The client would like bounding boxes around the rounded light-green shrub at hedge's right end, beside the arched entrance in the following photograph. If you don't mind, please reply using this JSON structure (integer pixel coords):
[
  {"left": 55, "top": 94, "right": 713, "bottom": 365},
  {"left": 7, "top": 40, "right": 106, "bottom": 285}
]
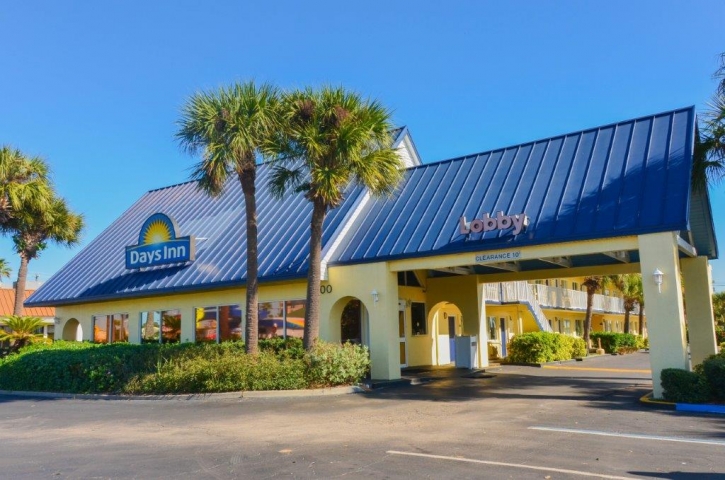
[{"left": 307, "top": 341, "right": 370, "bottom": 387}]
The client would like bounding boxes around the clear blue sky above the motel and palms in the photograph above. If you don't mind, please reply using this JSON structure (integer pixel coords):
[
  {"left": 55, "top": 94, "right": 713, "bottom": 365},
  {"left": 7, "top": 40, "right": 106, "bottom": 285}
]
[{"left": 0, "top": 0, "right": 725, "bottom": 288}]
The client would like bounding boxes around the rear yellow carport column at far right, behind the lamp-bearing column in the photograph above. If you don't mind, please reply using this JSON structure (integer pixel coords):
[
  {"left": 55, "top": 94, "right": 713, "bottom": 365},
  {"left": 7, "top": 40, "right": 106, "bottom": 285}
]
[{"left": 680, "top": 257, "right": 717, "bottom": 366}]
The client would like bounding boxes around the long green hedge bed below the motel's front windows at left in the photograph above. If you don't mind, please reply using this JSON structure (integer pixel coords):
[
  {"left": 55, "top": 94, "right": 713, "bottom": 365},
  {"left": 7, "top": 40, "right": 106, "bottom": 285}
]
[{"left": 0, "top": 339, "right": 370, "bottom": 394}]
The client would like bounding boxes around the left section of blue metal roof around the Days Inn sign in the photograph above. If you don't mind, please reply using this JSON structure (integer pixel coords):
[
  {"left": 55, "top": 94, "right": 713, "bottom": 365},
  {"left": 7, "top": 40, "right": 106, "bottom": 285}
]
[{"left": 26, "top": 165, "right": 362, "bottom": 305}]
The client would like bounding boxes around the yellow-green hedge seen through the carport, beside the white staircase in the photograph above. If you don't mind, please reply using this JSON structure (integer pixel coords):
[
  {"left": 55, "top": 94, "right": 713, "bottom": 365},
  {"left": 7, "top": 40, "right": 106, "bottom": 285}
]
[{"left": 507, "top": 332, "right": 587, "bottom": 363}]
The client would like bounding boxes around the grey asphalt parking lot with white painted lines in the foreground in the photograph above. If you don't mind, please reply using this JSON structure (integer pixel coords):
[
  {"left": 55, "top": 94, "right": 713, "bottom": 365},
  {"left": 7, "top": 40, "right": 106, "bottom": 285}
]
[{"left": 0, "top": 353, "right": 725, "bottom": 479}]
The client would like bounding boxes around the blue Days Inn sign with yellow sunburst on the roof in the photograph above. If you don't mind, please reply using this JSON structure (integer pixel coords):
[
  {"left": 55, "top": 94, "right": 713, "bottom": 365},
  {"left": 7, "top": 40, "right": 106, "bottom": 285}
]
[{"left": 126, "top": 213, "right": 196, "bottom": 270}]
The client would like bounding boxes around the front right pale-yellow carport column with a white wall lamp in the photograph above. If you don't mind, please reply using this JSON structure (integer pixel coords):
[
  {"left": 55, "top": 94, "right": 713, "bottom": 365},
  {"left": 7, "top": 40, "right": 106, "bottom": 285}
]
[{"left": 639, "top": 232, "right": 690, "bottom": 398}]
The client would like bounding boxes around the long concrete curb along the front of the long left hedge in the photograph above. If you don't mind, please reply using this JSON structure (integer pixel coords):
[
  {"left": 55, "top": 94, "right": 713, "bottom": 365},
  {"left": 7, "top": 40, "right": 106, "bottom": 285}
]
[{"left": 0, "top": 385, "right": 369, "bottom": 402}]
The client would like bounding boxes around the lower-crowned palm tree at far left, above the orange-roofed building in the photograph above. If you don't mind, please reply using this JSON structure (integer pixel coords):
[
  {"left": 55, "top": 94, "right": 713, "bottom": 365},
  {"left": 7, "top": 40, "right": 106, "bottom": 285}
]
[{"left": 10, "top": 197, "right": 83, "bottom": 315}]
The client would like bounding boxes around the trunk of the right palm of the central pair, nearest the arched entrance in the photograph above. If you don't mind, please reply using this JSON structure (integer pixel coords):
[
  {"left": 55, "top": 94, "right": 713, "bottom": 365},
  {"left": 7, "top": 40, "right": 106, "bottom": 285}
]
[{"left": 303, "top": 200, "right": 327, "bottom": 350}]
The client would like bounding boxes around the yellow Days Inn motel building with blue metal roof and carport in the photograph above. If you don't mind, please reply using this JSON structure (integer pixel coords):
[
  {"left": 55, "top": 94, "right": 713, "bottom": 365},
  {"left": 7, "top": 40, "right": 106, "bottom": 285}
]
[{"left": 27, "top": 107, "right": 718, "bottom": 394}]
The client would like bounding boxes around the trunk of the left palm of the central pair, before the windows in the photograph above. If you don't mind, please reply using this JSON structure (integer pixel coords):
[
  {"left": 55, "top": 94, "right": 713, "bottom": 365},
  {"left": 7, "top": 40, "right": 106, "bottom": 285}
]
[{"left": 238, "top": 171, "right": 259, "bottom": 354}]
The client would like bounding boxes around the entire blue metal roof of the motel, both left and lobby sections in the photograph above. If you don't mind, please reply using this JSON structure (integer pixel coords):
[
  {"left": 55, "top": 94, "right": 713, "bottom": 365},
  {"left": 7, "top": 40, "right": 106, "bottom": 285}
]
[{"left": 26, "top": 107, "right": 699, "bottom": 306}]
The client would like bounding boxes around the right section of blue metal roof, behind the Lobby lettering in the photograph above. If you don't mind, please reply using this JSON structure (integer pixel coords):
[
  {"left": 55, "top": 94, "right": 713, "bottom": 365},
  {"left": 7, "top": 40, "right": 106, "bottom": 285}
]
[{"left": 331, "top": 107, "right": 695, "bottom": 263}]
